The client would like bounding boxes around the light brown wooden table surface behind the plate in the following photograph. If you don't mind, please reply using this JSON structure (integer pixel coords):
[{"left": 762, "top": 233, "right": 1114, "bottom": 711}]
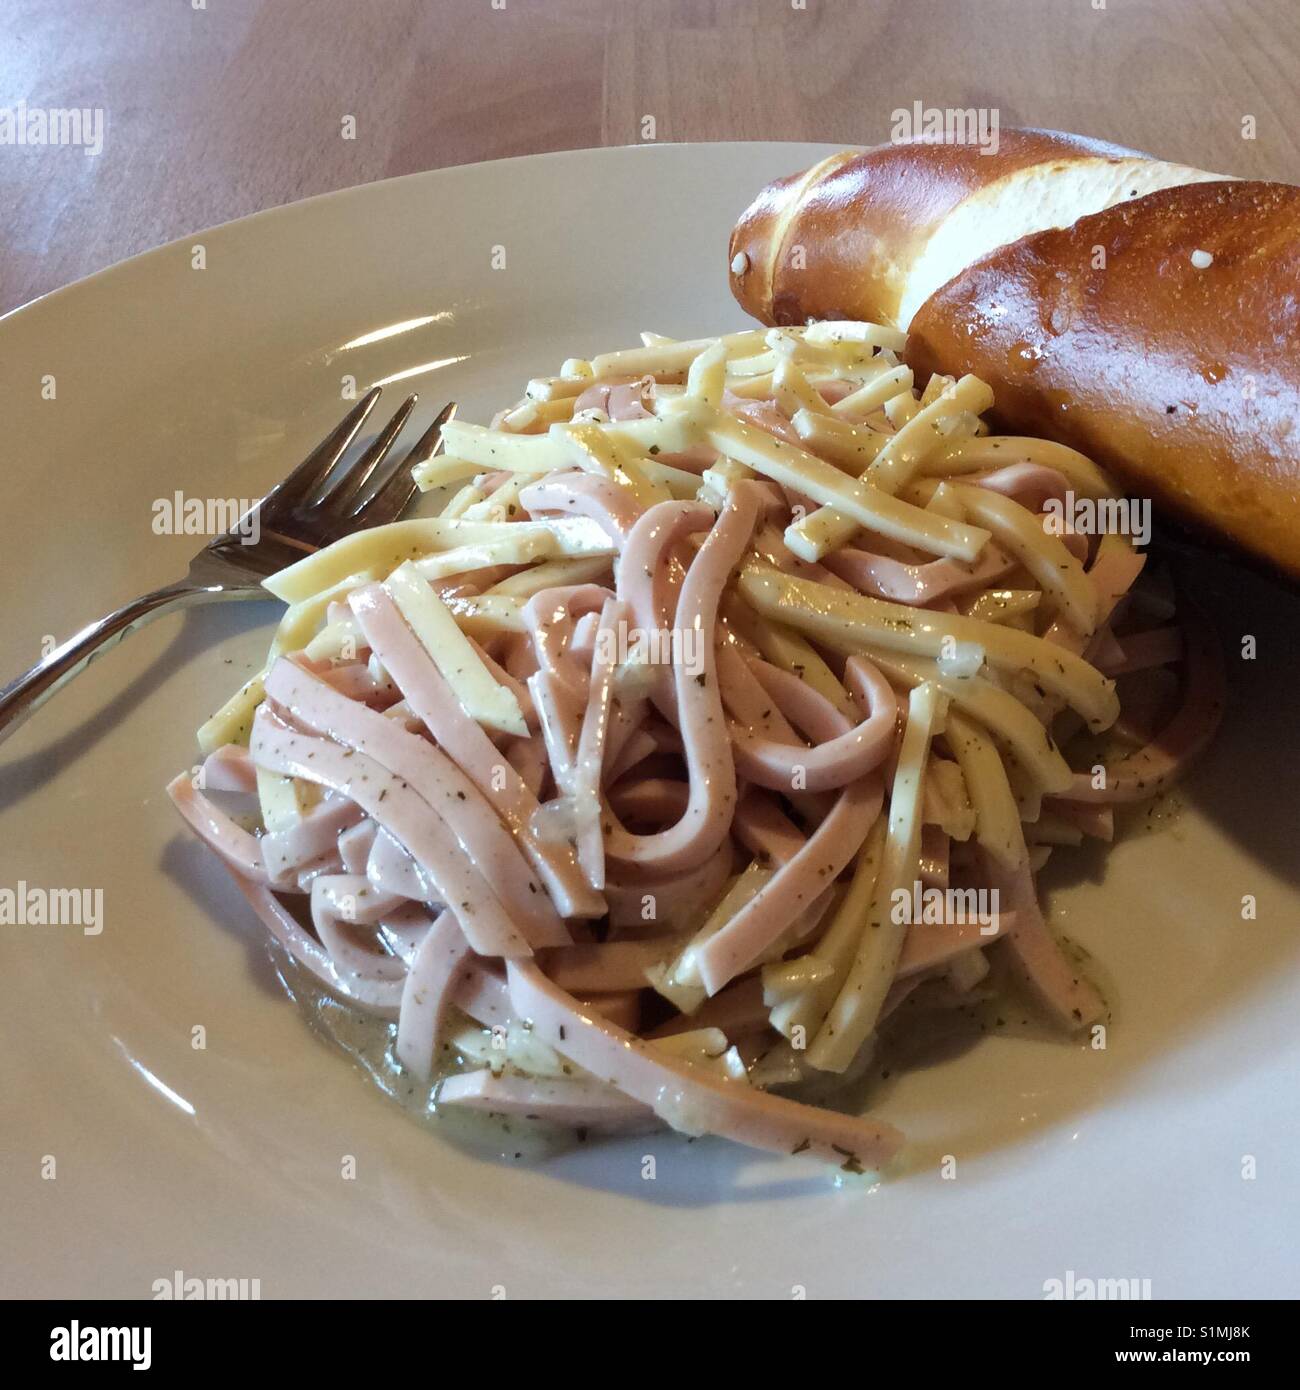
[{"left": 0, "top": 0, "right": 1300, "bottom": 310}]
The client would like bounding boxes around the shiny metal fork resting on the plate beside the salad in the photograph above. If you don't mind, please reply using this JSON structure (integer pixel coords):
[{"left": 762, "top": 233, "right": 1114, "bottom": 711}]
[{"left": 0, "top": 386, "right": 456, "bottom": 741}]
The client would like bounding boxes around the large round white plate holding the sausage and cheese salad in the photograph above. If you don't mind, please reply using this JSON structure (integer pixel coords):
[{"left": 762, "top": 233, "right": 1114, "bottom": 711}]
[{"left": 0, "top": 145, "right": 1300, "bottom": 1297}]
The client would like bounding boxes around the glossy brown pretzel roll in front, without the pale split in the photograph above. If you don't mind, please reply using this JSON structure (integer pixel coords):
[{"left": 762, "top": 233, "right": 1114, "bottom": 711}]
[{"left": 907, "top": 182, "right": 1300, "bottom": 578}]
